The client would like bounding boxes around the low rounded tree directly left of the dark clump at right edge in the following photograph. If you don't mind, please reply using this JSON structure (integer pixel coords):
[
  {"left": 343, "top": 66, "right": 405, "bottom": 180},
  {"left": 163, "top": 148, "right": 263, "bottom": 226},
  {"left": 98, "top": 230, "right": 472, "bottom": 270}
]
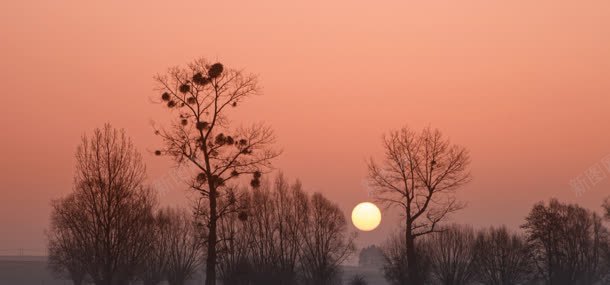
[{"left": 475, "top": 226, "right": 536, "bottom": 285}]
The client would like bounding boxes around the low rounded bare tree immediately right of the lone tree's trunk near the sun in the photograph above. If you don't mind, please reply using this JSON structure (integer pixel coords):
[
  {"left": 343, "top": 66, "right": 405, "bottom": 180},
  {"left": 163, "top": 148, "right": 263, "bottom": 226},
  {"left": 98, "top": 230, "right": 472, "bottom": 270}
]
[{"left": 426, "top": 225, "right": 477, "bottom": 285}]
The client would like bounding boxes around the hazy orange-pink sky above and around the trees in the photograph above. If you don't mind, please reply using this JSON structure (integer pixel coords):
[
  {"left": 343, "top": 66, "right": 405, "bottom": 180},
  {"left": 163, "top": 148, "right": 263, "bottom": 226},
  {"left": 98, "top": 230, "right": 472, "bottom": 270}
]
[{"left": 0, "top": 0, "right": 610, "bottom": 254}]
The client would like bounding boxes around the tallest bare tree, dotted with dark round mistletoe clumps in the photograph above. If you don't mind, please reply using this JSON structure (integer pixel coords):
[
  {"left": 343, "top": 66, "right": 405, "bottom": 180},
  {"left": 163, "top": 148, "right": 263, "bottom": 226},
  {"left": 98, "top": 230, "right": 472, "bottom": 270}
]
[{"left": 155, "top": 59, "right": 279, "bottom": 285}]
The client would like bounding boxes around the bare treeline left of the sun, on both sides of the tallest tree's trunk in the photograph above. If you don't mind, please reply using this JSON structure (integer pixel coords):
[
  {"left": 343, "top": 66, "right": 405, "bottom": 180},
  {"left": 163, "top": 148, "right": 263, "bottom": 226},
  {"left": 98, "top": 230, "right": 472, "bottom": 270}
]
[{"left": 47, "top": 125, "right": 355, "bottom": 285}]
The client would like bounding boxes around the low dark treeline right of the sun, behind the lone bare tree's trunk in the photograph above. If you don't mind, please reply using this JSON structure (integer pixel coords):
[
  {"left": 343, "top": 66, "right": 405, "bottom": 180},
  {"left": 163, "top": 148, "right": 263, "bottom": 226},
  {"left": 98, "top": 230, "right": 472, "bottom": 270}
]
[{"left": 383, "top": 199, "right": 610, "bottom": 285}]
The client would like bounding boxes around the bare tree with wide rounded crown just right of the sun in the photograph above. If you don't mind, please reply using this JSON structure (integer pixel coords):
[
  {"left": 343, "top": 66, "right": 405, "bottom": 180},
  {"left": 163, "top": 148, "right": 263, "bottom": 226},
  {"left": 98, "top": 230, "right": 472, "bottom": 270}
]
[{"left": 368, "top": 127, "right": 471, "bottom": 284}]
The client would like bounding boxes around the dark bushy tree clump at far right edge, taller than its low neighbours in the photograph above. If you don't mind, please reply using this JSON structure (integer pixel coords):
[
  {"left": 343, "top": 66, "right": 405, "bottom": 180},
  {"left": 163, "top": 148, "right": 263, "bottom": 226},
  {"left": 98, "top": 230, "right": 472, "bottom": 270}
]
[{"left": 522, "top": 199, "right": 610, "bottom": 285}]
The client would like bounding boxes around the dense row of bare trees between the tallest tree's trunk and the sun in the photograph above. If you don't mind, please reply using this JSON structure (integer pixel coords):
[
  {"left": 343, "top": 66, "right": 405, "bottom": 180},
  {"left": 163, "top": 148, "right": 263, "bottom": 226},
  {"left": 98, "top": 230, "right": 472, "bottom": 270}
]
[{"left": 208, "top": 174, "right": 355, "bottom": 285}]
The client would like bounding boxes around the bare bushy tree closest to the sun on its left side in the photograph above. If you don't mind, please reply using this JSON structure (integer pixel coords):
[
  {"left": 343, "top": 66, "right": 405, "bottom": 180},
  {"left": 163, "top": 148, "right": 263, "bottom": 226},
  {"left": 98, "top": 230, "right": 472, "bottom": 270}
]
[{"left": 301, "top": 193, "right": 355, "bottom": 285}]
